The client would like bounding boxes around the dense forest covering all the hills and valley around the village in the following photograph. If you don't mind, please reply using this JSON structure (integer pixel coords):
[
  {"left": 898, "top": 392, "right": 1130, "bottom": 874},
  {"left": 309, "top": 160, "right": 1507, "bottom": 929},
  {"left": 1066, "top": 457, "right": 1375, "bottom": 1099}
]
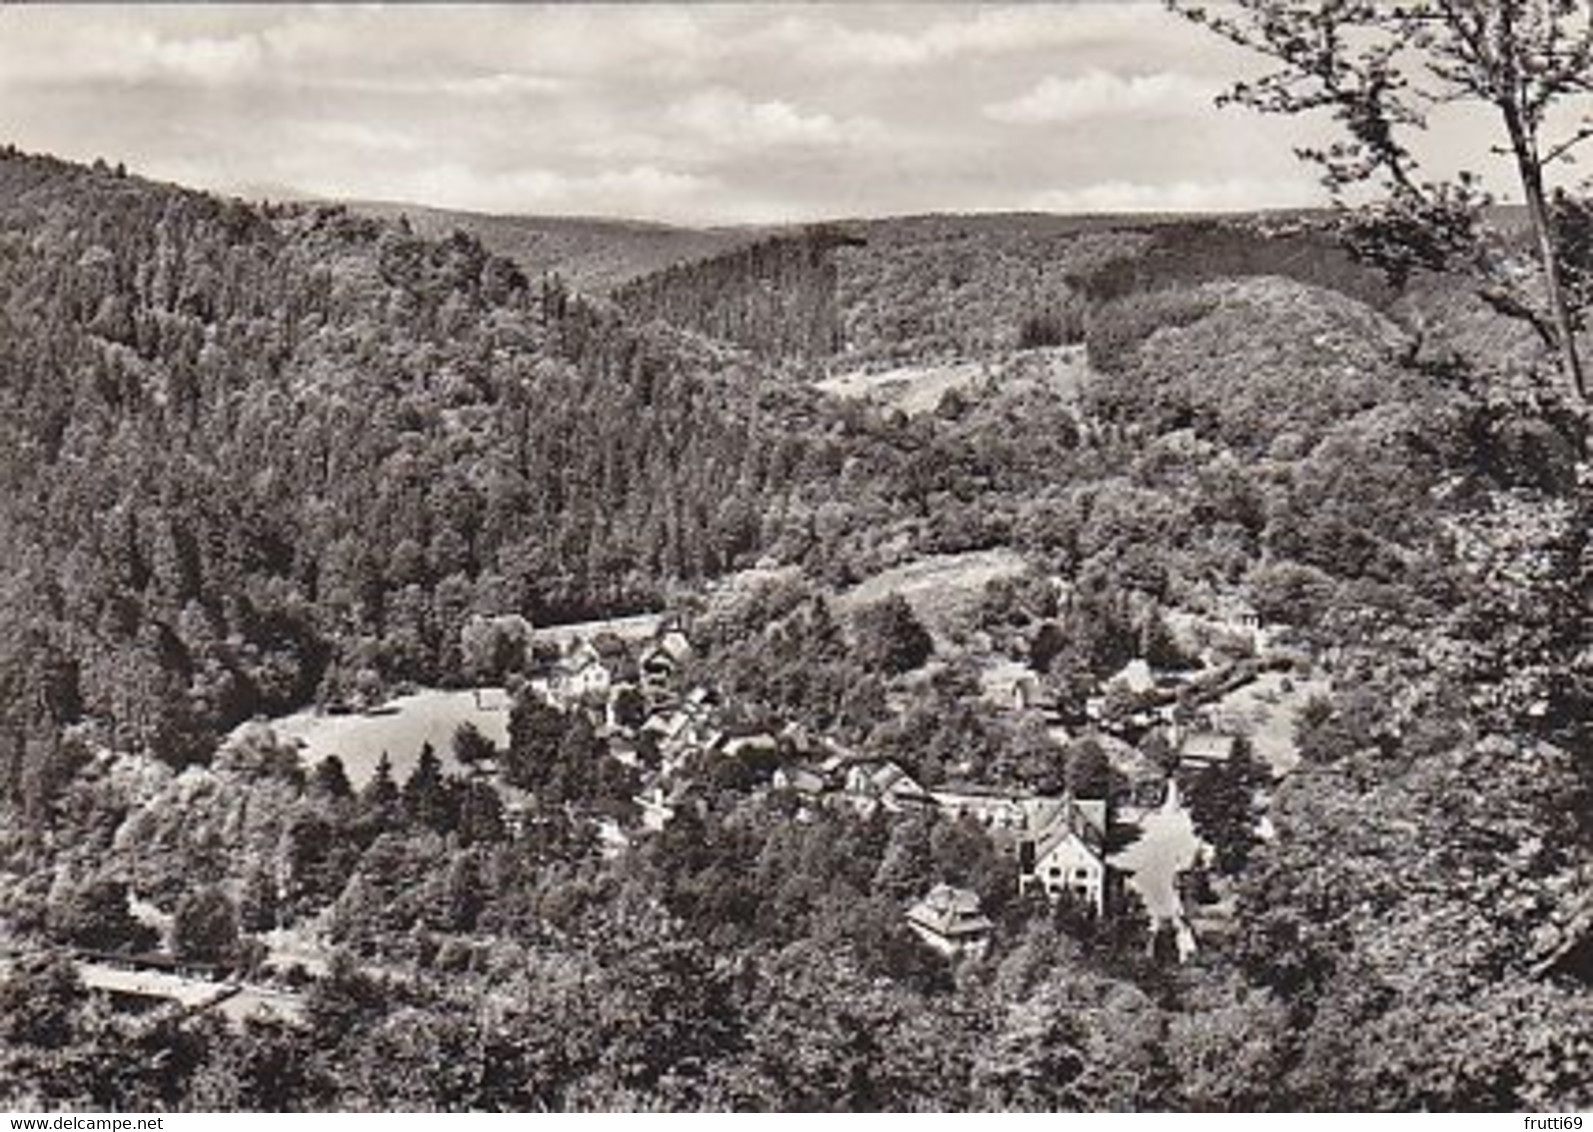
[{"left": 0, "top": 150, "right": 1593, "bottom": 1110}]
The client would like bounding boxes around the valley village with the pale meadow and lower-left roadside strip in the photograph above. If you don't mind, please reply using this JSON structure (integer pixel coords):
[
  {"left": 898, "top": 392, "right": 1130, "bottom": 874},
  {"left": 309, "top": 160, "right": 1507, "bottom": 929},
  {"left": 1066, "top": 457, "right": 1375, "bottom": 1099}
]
[{"left": 6, "top": 579, "right": 1325, "bottom": 1021}]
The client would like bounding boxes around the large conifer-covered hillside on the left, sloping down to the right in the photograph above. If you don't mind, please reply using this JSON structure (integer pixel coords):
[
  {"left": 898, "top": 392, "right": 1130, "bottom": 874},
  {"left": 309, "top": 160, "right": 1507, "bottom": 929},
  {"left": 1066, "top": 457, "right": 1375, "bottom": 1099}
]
[{"left": 0, "top": 151, "right": 860, "bottom": 791}]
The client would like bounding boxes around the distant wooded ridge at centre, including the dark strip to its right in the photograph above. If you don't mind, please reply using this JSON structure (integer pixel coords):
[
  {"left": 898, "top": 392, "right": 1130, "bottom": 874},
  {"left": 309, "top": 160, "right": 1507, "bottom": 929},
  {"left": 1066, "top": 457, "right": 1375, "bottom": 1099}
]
[{"left": 613, "top": 212, "right": 1392, "bottom": 374}]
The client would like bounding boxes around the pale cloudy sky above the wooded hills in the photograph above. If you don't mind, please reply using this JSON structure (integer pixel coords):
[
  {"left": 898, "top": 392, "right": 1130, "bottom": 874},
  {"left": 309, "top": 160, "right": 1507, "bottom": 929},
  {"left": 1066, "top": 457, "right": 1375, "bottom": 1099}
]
[{"left": 0, "top": 0, "right": 1497, "bottom": 224}]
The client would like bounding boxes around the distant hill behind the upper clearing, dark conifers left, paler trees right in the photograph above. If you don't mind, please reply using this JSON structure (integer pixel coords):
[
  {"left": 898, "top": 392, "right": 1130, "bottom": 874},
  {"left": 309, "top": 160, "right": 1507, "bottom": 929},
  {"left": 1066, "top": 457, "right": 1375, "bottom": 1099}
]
[{"left": 615, "top": 215, "right": 1121, "bottom": 373}]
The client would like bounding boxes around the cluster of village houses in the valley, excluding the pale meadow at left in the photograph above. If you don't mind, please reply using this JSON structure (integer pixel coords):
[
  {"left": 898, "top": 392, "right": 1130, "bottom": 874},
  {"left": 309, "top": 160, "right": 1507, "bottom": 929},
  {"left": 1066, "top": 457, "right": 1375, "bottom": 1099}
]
[{"left": 465, "top": 585, "right": 1327, "bottom": 958}]
